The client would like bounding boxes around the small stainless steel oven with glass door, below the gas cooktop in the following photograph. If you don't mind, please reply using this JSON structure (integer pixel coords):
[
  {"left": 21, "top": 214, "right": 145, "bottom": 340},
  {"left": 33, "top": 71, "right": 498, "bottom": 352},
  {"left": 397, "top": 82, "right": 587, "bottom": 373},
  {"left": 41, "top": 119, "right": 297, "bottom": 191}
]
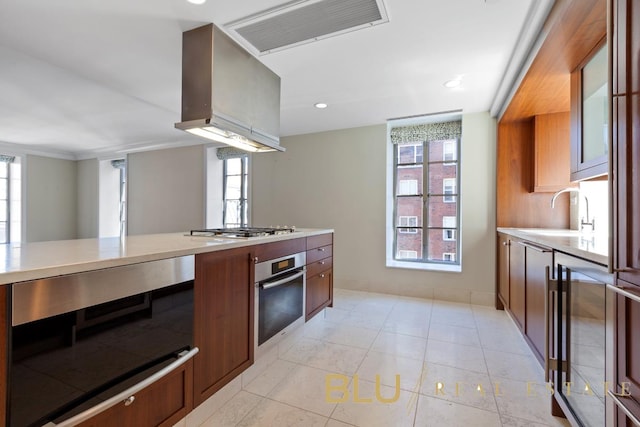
[{"left": 255, "top": 252, "right": 306, "bottom": 356}]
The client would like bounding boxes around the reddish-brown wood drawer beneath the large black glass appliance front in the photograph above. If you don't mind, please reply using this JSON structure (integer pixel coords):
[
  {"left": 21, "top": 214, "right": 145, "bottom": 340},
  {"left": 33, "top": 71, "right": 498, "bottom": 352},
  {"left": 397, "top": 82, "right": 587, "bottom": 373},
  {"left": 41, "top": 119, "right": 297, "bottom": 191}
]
[{"left": 79, "top": 360, "right": 193, "bottom": 427}]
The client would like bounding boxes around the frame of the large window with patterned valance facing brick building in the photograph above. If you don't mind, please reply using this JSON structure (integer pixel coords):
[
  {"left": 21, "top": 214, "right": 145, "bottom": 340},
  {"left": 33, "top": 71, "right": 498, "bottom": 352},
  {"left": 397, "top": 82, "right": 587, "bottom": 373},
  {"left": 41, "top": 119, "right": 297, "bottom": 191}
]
[{"left": 386, "top": 116, "right": 462, "bottom": 272}]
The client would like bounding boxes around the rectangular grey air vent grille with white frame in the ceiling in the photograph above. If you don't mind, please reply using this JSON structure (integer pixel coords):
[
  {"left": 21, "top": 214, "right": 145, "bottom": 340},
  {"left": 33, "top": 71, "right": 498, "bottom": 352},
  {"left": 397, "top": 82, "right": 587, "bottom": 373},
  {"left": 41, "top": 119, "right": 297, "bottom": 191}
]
[{"left": 225, "top": 0, "right": 389, "bottom": 55}]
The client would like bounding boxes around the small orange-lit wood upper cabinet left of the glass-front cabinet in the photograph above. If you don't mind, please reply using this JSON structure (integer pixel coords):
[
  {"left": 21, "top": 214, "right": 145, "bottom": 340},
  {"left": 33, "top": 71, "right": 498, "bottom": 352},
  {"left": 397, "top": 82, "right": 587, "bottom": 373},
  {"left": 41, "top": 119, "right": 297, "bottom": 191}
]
[{"left": 532, "top": 112, "right": 571, "bottom": 192}]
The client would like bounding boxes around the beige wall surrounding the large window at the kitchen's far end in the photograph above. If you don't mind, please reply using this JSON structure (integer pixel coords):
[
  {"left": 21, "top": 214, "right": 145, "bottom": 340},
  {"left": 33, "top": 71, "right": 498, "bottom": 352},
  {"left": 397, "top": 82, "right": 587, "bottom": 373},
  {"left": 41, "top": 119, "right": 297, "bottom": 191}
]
[{"left": 251, "top": 113, "right": 496, "bottom": 305}]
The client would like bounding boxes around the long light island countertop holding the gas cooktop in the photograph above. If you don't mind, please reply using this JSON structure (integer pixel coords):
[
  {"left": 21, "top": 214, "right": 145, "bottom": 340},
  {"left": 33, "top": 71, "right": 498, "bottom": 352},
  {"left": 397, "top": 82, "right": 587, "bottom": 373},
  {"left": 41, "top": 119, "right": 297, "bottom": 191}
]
[{"left": 0, "top": 228, "right": 333, "bottom": 284}]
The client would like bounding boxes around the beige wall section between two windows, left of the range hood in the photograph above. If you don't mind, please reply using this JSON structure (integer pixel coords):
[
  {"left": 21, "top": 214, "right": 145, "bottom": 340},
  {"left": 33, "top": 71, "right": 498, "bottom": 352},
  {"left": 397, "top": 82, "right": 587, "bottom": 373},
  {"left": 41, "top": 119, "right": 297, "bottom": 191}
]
[{"left": 127, "top": 145, "right": 206, "bottom": 234}]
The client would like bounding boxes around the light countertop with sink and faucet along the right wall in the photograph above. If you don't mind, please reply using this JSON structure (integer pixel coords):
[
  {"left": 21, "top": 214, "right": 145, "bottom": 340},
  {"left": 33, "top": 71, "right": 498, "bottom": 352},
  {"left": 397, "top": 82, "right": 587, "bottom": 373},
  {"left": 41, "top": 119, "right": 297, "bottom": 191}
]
[{"left": 498, "top": 227, "right": 609, "bottom": 266}]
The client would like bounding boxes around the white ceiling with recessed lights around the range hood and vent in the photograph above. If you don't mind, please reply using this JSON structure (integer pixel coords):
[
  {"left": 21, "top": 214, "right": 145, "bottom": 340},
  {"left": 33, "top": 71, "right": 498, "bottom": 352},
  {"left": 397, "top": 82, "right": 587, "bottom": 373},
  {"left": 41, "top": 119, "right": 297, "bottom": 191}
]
[{"left": 0, "top": 0, "right": 553, "bottom": 158}]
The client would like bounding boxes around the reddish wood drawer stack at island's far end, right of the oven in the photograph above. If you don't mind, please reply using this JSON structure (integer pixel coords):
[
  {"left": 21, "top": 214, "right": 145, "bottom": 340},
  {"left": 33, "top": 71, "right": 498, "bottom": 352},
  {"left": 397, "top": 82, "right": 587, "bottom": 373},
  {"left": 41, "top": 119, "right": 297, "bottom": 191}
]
[{"left": 305, "top": 233, "right": 333, "bottom": 321}]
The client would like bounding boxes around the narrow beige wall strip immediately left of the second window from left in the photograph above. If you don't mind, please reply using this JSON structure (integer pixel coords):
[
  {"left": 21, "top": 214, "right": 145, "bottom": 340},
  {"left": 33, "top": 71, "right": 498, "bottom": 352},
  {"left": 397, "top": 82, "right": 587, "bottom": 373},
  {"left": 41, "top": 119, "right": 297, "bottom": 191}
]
[{"left": 76, "top": 159, "right": 98, "bottom": 239}]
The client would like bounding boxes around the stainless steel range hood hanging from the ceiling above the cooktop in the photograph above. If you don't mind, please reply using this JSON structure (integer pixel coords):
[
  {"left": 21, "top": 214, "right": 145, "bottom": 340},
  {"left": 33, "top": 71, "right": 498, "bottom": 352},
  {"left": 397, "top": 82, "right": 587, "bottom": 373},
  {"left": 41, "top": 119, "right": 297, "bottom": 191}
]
[{"left": 175, "top": 24, "right": 285, "bottom": 152}]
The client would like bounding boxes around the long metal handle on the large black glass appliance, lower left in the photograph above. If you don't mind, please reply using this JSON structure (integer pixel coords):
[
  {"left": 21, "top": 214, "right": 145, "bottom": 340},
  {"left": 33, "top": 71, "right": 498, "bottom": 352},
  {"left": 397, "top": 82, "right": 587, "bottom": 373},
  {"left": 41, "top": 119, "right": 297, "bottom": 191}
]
[{"left": 43, "top": 347, "right": 199, "bottom": 427}]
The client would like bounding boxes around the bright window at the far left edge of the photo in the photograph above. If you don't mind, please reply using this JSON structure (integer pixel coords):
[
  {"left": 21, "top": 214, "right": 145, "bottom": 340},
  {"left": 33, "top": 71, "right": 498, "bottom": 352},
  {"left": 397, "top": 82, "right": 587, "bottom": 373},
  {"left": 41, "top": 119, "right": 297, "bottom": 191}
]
[{"left": 0, "top": 155, "right": 22, "bottom": 243}]
